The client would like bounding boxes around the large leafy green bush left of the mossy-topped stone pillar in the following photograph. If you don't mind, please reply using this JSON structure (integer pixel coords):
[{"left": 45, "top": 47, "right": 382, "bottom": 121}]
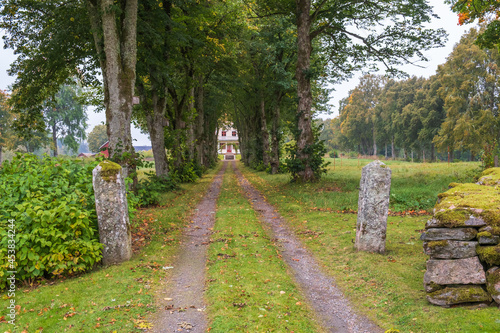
[{"left": 0, "top": 154, "right": 102, "bottom": 289}]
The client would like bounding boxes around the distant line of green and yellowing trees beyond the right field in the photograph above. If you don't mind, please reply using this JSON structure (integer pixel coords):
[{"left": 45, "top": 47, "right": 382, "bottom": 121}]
[{"left": 321, "top": 29, "right": 500, "bottom": 160}]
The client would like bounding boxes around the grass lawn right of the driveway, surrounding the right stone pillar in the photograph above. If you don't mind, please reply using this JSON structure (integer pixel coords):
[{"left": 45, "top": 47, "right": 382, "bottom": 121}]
[{"left": 241, "top": 159, "right": 500, "bottom": 333}]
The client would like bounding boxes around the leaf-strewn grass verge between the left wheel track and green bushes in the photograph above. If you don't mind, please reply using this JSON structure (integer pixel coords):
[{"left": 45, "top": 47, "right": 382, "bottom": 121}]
[{"left": 0, "top": 163, "right": 223, "bottom": 333}]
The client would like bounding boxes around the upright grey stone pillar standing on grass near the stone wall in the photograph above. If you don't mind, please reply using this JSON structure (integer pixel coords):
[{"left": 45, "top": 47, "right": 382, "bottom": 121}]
[{"left": 354, "top": 160, "right": 391, "bottom": 253}]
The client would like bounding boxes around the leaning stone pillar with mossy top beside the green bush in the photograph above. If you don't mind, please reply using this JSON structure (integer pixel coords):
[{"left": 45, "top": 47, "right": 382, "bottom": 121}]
[{"left": 92, "top": 161, "right": 132, "bottom": 265}]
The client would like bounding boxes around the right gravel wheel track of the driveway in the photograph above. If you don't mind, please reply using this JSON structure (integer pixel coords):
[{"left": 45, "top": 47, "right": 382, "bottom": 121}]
[{"left": 231, "top": 162, "right": 383, "bottom": 333}]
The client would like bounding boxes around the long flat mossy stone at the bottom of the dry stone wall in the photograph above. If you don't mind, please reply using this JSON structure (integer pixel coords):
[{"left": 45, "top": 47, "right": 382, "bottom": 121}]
[{"left": 427, "top": 286, "right": 491, "bottom": 306}]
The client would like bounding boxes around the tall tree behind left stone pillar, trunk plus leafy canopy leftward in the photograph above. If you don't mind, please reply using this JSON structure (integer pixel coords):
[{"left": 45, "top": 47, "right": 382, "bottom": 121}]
[{"left": 0, "top": 0, "right": 138, "bottom": 175}]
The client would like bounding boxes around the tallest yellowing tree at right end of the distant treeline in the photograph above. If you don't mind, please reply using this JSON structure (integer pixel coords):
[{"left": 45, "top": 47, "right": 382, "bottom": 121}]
[{"left": 434, "top": 29, "right": 500, "bottom": 155}]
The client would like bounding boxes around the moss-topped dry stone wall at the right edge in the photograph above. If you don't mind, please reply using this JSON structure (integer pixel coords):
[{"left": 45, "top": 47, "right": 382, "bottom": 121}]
[{"left": 421, "top": 168, "right": 500, "bottom": 307}]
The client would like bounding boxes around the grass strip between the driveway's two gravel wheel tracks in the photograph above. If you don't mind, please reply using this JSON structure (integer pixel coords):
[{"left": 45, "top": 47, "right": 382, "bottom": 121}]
[{"left": 207, "top": 167, "right": 322, "bottom": 333}]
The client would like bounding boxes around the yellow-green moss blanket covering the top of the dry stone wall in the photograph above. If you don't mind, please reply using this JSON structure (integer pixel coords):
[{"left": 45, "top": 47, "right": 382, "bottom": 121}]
[{"left": 434, "top": 184, "right": 500, "bottom": 228}]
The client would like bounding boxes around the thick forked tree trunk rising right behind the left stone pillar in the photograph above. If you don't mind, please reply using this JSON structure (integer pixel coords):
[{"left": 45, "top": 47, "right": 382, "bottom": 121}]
[{"left": 87, "top": 0, "right": 138, "bottom": 177}]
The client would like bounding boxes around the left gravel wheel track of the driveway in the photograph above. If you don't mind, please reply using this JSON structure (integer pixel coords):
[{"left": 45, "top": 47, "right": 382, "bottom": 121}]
[{"left": 151, "top": 162, "right": 227, "bottom": 333}]
